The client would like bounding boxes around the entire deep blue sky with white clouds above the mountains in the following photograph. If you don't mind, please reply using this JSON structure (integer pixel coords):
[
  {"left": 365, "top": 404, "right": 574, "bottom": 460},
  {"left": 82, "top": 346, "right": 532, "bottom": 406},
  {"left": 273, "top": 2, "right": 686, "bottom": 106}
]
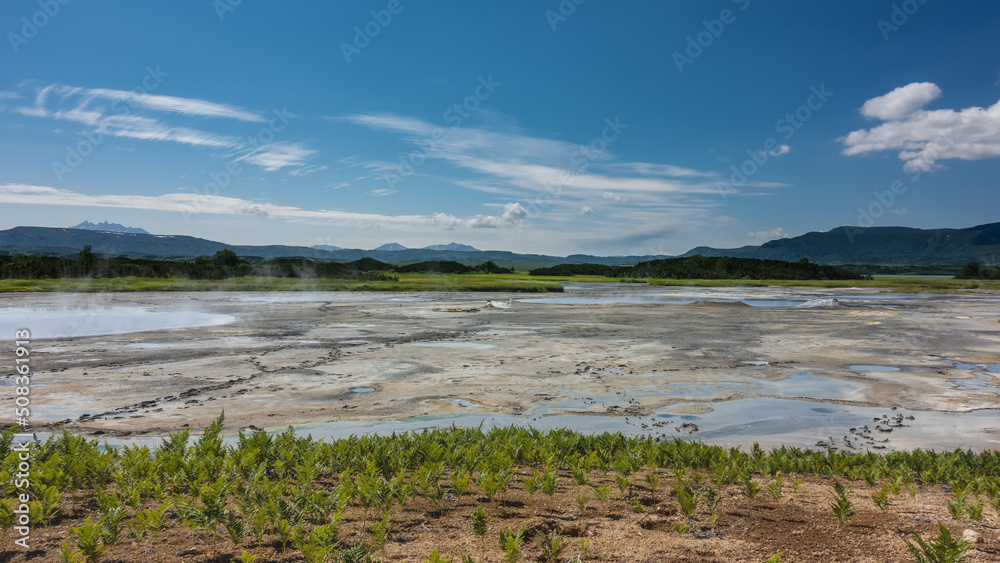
[{"left": 0, "top": 0, "right": 1000, "bottom": 255}]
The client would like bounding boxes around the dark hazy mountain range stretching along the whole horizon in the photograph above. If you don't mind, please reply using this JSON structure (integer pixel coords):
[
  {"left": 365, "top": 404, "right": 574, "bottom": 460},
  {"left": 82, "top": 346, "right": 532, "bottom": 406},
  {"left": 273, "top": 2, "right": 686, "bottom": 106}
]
[{"left": 0, "top": 222, "right": 1000, "bottom": 266}]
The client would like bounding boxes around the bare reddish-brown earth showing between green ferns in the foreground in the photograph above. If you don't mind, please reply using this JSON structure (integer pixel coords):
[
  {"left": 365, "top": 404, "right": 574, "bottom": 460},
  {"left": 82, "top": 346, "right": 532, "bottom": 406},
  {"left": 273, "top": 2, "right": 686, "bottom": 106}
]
[{"left": 3, "top": 471, "right": 1000, "bottom": 563}]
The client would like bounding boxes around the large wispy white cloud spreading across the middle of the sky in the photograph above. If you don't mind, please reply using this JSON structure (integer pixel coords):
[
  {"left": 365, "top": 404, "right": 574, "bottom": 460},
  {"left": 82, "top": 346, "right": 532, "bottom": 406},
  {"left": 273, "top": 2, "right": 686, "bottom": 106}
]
[{"left": 337, "top": 113, "right": 789, "bottom": 250}]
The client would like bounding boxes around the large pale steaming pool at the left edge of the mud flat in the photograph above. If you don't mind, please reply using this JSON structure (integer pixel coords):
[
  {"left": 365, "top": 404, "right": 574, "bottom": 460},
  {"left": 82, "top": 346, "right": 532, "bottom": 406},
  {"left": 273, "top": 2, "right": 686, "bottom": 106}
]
[{"left": 0, "top": 307, "right": 236, "bottom": 340}]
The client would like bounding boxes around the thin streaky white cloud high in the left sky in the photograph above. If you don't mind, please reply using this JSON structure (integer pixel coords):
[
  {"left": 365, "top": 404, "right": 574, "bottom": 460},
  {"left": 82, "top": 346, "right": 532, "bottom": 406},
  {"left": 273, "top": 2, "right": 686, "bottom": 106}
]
[{"left": 8, "top": 83, "right": 316, "bottom": 171}]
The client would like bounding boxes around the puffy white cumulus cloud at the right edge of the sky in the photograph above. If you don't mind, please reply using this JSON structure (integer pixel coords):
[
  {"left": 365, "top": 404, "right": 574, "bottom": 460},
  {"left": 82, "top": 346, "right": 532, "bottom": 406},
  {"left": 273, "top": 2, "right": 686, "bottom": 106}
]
[{"left": 839, "top": 82, "right": 1000, "bottom": 172}]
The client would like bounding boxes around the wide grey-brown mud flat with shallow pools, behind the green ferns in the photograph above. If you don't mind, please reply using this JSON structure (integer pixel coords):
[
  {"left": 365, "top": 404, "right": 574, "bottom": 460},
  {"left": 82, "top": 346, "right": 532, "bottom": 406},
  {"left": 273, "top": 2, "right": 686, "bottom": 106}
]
[{"left": 0, "top": 284, "right": 1000, "bottom": 451}]
